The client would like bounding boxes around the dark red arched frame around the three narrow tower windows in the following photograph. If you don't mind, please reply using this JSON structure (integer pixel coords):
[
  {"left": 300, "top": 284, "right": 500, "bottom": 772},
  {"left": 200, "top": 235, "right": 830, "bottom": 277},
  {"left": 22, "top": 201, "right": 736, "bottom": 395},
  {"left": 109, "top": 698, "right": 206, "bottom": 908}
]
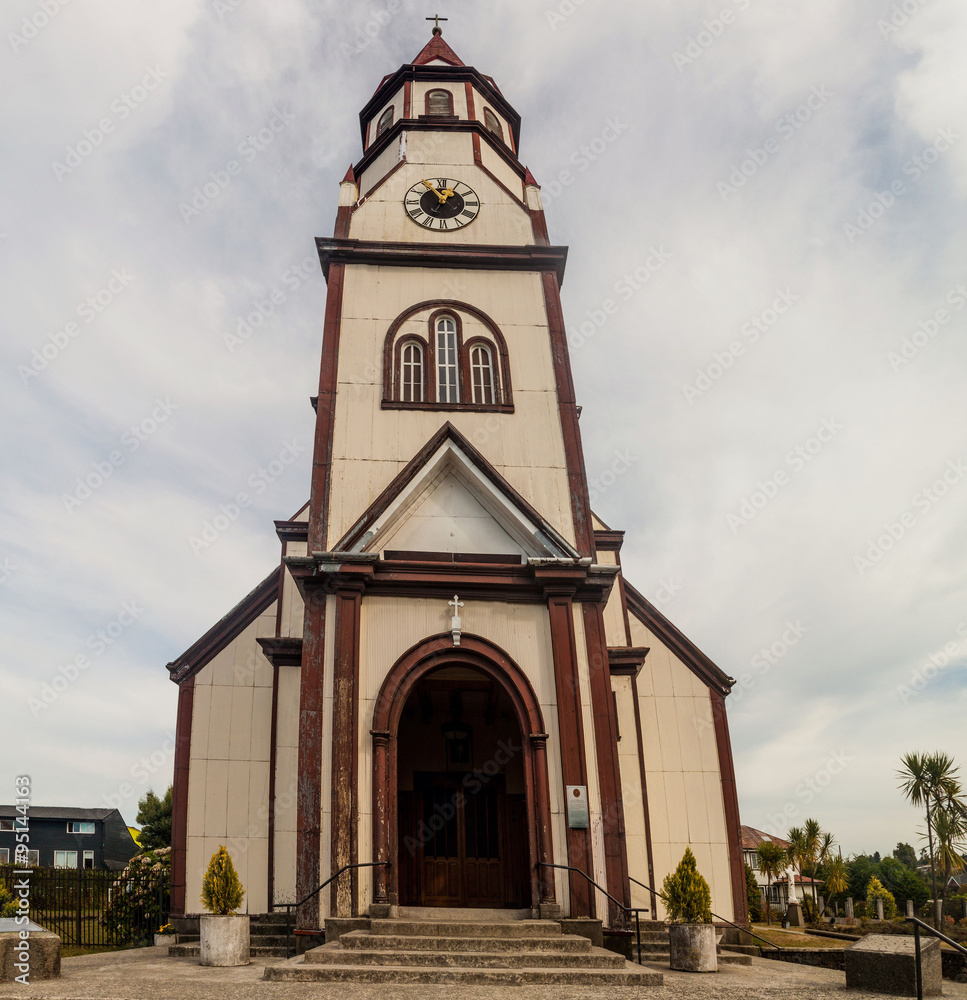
[{"left": 381, "top": 299, "right": 514, "bottom": 413}]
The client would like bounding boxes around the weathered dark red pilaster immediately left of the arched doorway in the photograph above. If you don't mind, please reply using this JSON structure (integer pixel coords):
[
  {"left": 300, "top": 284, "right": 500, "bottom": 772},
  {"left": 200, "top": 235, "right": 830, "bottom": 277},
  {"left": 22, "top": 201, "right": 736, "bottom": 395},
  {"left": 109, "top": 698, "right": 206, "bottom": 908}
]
[{"left": 330, "top": 587, "right": 362, "bottom": 917}]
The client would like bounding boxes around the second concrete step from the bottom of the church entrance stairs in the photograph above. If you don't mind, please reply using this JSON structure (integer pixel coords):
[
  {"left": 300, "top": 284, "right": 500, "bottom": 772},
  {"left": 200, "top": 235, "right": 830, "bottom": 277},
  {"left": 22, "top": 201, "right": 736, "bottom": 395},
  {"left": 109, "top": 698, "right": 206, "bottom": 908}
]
[{"left": 305, "top": 944, "right": 625, "bottom": 969}]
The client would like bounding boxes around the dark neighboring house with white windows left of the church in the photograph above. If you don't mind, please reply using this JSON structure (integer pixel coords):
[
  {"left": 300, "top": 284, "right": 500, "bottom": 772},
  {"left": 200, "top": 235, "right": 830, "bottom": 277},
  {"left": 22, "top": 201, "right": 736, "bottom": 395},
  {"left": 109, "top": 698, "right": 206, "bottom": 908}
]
[{"left": 0, "top": 806, "right": 138, "bottom": 871}]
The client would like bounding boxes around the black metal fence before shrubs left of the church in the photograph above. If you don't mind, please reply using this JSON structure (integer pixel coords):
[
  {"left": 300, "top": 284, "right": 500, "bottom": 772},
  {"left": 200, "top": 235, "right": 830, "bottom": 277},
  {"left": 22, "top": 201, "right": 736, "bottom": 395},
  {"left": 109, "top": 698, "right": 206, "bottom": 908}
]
[{"left": 0, "top": 866, "right": 171, "bottom": 948}]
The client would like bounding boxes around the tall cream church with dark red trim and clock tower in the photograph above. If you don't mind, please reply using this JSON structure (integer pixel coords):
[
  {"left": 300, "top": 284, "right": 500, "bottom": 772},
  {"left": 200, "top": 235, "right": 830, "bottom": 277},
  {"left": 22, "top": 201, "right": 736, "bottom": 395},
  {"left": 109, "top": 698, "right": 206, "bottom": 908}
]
[{"left": 168, "top": 27, "right": 746, "bottom": 934}]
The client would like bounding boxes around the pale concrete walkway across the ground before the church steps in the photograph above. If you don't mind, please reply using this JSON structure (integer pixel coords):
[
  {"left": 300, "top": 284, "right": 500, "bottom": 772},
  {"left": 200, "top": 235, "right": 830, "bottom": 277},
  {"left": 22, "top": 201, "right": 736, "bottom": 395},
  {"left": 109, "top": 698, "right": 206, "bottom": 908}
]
[{"left": 0, "top": 948, "right": 967, "bottom": 1000}]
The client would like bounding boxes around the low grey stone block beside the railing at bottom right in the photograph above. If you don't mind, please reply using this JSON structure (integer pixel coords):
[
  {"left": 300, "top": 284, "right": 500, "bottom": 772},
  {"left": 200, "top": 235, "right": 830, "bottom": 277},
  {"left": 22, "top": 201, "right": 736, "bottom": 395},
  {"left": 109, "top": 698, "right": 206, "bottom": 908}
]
[{"left": 844, "top": 934, "right": 942, "bottom": 997}]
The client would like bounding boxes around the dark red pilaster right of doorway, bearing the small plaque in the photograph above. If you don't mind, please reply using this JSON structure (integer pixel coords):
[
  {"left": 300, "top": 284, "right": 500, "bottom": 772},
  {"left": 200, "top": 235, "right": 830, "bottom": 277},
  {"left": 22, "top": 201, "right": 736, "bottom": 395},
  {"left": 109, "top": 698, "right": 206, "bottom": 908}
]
[{"left": 547, "top": 594, "right": 595, "bottom": 917}]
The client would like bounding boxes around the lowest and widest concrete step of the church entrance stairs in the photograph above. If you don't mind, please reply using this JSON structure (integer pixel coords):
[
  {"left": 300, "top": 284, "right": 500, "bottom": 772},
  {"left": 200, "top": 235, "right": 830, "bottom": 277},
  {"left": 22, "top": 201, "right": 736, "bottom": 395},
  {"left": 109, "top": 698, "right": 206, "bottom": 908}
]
[{"left": 263, "top": 963, "right": 663, "bottom": 987}]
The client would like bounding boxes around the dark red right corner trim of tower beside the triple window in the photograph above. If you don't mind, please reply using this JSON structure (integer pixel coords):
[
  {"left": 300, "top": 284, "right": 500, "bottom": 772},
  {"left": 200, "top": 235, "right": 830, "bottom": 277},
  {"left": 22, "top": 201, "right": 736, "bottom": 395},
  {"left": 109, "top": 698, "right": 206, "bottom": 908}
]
[{"left": 542, "top": 271, "right": 594, "bottom": 556}]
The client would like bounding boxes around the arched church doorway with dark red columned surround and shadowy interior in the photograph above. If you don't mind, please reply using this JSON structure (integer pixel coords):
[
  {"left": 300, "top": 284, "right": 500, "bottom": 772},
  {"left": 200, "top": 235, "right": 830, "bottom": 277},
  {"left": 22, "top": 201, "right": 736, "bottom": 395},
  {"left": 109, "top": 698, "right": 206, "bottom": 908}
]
[{"left": 372, "top": 634, "right": 554, "bottom": 908}]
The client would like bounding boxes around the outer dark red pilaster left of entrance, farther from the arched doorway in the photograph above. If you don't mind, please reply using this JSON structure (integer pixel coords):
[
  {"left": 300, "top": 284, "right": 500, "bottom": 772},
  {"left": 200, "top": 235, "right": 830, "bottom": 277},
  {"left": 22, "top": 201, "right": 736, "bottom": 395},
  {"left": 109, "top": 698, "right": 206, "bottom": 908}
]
[{"left": 296, "top": 590, "right": 326, "bottom": 929}]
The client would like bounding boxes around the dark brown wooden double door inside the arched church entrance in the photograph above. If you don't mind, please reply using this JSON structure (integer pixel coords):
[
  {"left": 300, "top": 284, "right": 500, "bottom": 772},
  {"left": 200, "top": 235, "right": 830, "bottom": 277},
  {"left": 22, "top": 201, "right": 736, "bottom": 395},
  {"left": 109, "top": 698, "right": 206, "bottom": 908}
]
[{"left": 399, "top": 773, "right": 530, "bottom": 908}]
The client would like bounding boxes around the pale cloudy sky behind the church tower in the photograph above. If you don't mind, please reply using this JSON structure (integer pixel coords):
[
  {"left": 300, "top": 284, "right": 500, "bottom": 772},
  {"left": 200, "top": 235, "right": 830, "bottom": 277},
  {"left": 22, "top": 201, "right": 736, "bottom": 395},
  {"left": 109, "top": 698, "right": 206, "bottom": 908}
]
[{"left": 0, "top": 0, "right": 967, "bottom": 854}]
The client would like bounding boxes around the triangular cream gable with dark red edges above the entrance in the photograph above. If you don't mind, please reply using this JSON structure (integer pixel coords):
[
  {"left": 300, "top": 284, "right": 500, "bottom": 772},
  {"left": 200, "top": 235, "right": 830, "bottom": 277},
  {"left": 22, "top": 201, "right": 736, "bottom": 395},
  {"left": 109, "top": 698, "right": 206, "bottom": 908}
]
[{"left": 335, "top": 423, "right": 579, "bottom": 559}]
